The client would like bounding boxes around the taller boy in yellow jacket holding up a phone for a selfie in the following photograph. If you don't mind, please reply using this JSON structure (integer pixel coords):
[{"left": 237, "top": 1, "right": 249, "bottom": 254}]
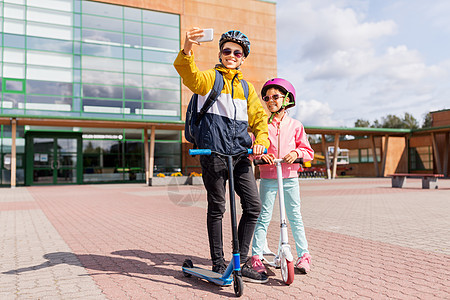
[{"left": 174, "top": 27, "right": 269, "bottom": 283}]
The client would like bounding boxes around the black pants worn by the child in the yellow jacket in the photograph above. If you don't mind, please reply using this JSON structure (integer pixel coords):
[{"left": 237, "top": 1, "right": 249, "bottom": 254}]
[{"left": 200, "top": 155, "right": 261, "bottom": 265}]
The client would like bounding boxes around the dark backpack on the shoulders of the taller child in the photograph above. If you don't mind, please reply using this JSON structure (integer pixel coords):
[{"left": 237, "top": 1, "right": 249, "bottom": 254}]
[{"left": 184, "top": 70, "right": 249, "bottom": 149}]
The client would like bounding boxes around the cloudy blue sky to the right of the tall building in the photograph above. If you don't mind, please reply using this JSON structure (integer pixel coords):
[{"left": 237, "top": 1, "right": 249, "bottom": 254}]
[{"left": 277, "top": 0, "right": 450, "bottom": 127}]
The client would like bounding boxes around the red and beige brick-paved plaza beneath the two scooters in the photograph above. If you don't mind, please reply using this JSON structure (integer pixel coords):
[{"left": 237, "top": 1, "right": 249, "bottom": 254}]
[{"left": 0, "top": 179, "right": 450, "bottom": 299}]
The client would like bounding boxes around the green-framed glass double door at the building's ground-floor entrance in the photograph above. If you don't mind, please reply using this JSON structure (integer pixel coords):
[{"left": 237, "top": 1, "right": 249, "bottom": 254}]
[{"left": 26, "top": 133, "right": 81, "bottom": 185}]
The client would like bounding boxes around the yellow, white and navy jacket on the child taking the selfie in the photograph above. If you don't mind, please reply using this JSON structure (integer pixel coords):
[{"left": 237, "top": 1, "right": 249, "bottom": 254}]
[{"left": 174, "top": 51, "right": 270, "bottom": 154}]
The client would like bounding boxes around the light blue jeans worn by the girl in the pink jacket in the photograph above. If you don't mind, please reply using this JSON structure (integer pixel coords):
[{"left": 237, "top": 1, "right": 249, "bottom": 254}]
[{"left": 252, "top": 178, "right": 308, "bottom": 257}]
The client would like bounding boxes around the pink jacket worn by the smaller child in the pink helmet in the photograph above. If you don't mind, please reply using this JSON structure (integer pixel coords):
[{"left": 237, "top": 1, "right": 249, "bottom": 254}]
[{"left": 259, "top": 115, "right": 314, "bottom": 179}]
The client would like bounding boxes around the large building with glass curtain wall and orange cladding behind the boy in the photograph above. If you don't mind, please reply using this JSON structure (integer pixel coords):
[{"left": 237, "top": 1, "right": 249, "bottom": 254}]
[{"left": 0, "top": 0, "right": 277, "bottom": 186}]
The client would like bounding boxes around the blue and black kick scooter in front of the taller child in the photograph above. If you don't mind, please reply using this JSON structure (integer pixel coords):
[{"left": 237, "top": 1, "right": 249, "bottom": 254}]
[{"left": 183, "top": 149, "right": 267, "bottom": 297}]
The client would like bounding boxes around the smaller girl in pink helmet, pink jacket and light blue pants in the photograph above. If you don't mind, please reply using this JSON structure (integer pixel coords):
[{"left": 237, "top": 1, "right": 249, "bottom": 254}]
[{"left": 252, "top": 78, "right": 314, "bottom": 274}]
